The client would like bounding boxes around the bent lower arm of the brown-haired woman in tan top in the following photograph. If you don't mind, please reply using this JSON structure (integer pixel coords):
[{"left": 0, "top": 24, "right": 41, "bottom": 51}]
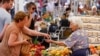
[{"left": 8, "top": 32, "right": 28, "bottom": 46}]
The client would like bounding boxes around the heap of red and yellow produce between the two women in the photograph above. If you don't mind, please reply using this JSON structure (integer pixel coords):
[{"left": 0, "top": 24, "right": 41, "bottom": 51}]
[{"left": 30, "top": 45, "right": 72, "bottom": 56}]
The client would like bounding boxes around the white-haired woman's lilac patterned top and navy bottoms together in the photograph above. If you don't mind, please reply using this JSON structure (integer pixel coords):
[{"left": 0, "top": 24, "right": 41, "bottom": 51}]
[{"left": 64, "top": 29, "right": 89, "bottom": 56}]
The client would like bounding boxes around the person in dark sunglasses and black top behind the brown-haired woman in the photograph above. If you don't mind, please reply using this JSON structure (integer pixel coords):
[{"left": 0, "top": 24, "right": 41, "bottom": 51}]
[{"left": 26, "top": 2, "right": 37, "bottom": 43}]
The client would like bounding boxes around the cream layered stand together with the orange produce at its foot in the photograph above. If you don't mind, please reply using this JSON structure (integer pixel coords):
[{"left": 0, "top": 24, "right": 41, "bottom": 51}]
[{"left": 79, "top": 16, "right": 100, "bottom": 56}]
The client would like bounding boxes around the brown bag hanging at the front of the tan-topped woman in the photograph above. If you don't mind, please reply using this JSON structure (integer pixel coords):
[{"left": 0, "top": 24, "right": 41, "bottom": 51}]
[{"left": 20, "top": 34, "right": 32, "bottom": 56}]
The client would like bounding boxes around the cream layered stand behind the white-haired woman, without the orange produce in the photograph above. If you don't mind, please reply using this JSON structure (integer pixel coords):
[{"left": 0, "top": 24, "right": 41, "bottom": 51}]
[{"left": 80, "top": 16, "right": 100, "bottom": 45}]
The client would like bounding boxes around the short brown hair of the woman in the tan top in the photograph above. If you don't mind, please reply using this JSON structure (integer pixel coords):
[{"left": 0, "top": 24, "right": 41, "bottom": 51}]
[{"left": 14, "top": 11, "right": 29, "bottom": 23}]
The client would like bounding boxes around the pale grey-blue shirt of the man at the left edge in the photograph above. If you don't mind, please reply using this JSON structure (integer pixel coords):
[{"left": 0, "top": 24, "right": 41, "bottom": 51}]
[{"left": 0, "top": 8, "right": 11, "bottom": 32}]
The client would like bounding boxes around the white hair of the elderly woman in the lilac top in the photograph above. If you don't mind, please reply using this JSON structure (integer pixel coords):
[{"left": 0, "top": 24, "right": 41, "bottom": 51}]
[{"left": 68, "top": 16, "right": 83, "bottom": 29}]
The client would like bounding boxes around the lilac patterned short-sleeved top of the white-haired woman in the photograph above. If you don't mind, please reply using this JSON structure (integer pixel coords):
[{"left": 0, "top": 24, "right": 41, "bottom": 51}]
[{"left": 64, "top": 30, "right": 89, "bottom": 51}]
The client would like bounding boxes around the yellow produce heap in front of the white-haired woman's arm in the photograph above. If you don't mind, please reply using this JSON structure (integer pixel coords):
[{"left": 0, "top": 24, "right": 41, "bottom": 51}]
[{"left": 47, "top": 46, "right": 72, "bottom": 56}]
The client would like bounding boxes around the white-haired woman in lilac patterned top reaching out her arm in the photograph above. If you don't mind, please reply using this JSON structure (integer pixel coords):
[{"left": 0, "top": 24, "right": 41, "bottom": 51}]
[{"left": 47, "top": 17, "right": 89, "bottom": 56}]
